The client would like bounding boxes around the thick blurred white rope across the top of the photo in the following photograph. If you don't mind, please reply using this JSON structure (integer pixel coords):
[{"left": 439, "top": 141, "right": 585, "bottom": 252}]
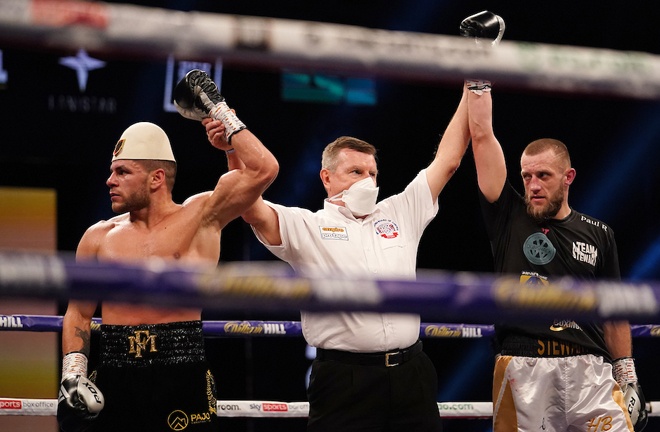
[{"left": 0, "top": 0, "right": 660, "bottom": 99}]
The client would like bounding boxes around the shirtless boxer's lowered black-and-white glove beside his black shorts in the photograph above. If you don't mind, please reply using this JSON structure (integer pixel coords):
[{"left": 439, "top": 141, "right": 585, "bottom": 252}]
[{"left": 57, "top": 352, "right": 105, "bottom": 432}]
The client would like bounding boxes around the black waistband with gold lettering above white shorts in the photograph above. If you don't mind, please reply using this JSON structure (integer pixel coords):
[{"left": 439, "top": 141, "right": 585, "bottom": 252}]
[{"left": 500, "top": 335, "right": 600, "bottom": 357}]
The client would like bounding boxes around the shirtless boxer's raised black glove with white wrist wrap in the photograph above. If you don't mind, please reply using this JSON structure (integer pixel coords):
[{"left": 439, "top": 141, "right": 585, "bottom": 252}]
[{"left": 174, "top": 69, "right": 245, "bottom": 141}]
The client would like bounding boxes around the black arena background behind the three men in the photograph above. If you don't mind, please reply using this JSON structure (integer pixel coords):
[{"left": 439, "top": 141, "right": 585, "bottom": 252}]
[{"left": 0, "top": 0, "right": 660, "bottom": 431}]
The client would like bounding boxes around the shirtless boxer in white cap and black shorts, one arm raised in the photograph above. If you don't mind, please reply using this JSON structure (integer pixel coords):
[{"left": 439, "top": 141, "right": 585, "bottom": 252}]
[{"left": 58, "top": 74, "right": 279, "bottom": 432}]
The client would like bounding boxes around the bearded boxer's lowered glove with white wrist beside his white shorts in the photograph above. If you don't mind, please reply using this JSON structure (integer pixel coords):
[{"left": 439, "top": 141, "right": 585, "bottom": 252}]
[{"left": 612, "top": 357, "right": 649, "bottom": 432}]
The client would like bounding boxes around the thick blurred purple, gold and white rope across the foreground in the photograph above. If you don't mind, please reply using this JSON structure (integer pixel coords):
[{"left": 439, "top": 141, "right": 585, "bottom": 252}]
[{"left": 0, "top": 253, "right": 660, "bottom": 323}]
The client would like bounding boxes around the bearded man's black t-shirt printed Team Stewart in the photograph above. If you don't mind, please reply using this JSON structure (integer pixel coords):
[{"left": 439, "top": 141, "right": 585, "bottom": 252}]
[{"left": 480, "top": 182, "right": 621, "bottom": 360}]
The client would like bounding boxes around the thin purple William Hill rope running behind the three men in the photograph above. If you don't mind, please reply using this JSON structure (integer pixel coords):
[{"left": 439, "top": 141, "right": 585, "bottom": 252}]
[{"left": 0, "top": 314, "right": 660, "bottom": 339}]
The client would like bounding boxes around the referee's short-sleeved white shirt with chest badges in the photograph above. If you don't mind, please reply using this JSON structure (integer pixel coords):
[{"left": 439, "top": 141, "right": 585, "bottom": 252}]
[{"left": 255, "top": 170, "right": 438, "bottom": 352}]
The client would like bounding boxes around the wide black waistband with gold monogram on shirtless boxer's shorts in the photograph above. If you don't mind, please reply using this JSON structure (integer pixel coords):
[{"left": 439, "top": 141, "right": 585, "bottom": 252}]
[{"left": 100, "top": 321, "right": 205, "bottom": 367}]
